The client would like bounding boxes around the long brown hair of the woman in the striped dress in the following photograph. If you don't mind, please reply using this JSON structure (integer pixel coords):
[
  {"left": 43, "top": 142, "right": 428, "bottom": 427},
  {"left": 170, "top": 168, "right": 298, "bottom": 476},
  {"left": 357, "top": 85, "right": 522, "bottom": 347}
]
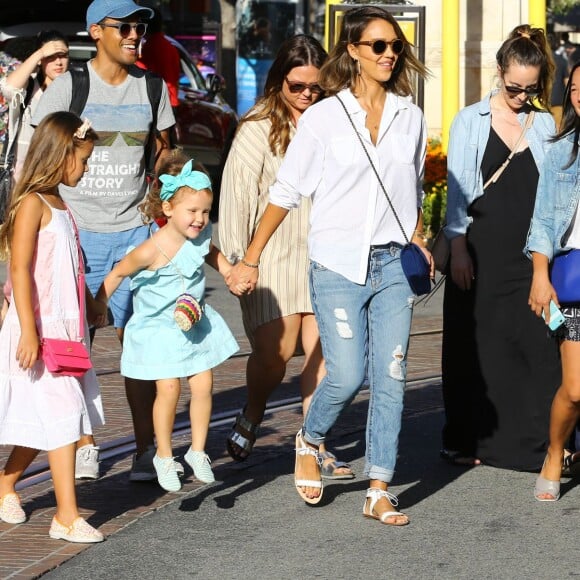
[{"left": 240, "top": 34, "right": 327, "bottom": 155}]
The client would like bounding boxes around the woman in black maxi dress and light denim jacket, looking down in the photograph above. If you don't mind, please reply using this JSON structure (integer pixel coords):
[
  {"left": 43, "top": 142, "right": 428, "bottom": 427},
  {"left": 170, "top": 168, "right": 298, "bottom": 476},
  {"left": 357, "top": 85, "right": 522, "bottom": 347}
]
[{"left": 441, "top": 25, "right": 560, "bottom": 470}]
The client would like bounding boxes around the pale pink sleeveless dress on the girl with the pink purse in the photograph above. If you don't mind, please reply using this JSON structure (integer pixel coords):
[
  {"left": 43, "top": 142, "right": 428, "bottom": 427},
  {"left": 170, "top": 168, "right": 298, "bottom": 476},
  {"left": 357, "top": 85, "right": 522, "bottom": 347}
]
[{"left": 0, "top": 204, "right": 104, "bottom": 450}]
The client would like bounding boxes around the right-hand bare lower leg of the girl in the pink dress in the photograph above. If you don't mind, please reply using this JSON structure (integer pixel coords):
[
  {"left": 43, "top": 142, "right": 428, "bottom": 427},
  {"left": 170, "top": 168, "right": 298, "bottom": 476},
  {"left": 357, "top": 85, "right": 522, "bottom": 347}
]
[{"left": 48, "top": 443, "right": 79, "bottom": 526}]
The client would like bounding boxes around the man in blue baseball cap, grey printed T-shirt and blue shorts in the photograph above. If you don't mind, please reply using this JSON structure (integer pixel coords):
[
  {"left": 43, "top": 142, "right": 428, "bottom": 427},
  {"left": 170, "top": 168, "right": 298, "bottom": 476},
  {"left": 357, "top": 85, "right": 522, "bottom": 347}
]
[{"left": 32, "top": 0, "right": 174, "bottom": 481}]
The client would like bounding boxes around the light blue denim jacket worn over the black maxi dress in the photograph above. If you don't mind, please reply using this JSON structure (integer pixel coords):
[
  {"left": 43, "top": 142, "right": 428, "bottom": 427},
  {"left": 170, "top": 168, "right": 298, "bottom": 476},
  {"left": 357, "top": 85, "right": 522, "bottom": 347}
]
[{"left": 445, "top": 92, "right": 556, "bottom": 239}]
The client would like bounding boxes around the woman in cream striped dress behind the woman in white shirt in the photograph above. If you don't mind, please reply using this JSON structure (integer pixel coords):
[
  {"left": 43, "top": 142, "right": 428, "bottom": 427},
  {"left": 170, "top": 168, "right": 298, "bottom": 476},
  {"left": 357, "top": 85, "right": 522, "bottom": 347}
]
[{"left": 219, "top": 34, "right": 353, "bottom": 478}]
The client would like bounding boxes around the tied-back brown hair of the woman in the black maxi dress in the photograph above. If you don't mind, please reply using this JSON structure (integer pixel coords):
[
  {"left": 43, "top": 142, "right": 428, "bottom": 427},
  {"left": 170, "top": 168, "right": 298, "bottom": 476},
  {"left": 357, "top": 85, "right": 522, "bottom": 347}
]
[{"left": 495, "top": 24, "right": 556, "bottom": 111}]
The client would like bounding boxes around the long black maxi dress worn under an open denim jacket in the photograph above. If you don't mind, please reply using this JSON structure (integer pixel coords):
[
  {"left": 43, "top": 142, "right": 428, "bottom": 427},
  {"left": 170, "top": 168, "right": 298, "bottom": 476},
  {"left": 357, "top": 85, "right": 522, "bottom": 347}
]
[{"left": 442, "top": 128, "right": 561, "bottom": 471}]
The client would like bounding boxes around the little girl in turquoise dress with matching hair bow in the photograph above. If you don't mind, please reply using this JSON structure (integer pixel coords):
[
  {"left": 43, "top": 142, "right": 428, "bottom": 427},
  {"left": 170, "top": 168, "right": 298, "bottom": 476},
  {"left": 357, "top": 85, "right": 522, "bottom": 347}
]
[{"left": 96, "top": 158, "right": 239, "bottom": 491}]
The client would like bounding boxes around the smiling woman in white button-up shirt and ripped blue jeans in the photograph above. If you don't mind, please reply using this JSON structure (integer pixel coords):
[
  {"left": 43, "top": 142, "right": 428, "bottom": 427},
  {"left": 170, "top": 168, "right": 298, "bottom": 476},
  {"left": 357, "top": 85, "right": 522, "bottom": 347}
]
[{"left": 231, "top": 6, "right": 430, "bottom": 525}]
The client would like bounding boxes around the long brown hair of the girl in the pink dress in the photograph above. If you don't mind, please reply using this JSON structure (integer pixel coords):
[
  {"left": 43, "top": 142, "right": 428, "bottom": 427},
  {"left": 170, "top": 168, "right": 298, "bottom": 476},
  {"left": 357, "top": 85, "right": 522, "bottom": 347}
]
[{"left": 0, "top": 111, "right": 98, "bottom": 260}]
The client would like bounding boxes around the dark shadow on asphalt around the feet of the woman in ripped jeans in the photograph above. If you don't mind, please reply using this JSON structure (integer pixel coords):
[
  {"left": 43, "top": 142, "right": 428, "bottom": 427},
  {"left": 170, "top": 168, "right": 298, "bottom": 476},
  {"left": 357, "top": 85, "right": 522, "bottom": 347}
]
[{"left": 180, "top": 387, "right": 477, "bottom": 512}]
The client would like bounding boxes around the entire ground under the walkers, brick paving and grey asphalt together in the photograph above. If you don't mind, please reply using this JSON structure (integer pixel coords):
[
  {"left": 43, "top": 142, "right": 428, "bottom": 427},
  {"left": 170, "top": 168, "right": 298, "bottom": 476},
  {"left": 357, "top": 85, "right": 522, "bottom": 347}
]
[{"left": 0, "top": 268, "right": 580, "bottom": 580}]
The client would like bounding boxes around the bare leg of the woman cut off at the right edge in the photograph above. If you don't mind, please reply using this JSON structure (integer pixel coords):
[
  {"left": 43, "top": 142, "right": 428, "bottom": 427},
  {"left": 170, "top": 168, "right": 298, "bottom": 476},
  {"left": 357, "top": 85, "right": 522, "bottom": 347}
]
[{"left": 539, "top": 340, "right": 580, "bottom": 492}]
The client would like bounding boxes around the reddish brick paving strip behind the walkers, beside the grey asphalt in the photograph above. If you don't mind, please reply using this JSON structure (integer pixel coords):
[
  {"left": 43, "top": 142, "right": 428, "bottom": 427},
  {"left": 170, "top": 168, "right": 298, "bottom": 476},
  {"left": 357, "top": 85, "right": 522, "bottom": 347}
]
[{"left": 0, "top": 260, "right": 441, "bottom": 579}]
